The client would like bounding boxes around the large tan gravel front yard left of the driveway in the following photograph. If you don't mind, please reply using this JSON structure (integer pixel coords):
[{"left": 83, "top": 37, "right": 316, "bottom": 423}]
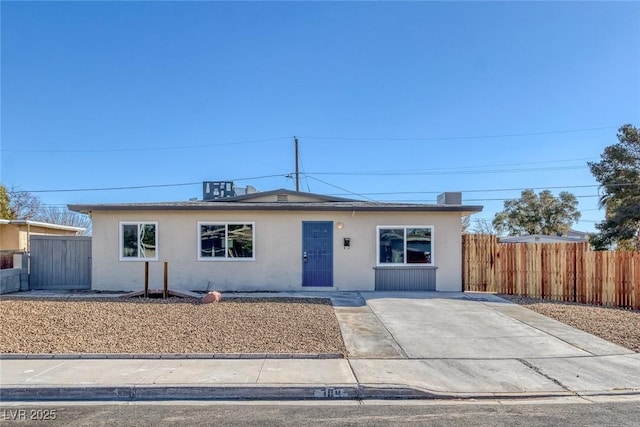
[{"left": 0, "top": 298, "right": 346, "bottom": 354}]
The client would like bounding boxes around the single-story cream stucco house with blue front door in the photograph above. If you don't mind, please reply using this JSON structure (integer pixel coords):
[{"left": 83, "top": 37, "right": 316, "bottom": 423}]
[{"left": 69, "top": 189, "right": 482, "bottom": 291}]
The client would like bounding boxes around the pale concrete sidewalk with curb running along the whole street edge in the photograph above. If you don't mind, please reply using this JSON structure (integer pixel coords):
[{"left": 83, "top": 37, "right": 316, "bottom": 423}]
[{"left": 0, "top": 353, "right": 640, "bottom": 401}]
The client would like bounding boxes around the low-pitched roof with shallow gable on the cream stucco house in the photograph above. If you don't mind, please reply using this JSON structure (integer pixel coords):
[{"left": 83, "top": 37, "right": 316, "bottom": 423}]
[{"left": 68, "top": 189, "right": 482, "bottom": 214}]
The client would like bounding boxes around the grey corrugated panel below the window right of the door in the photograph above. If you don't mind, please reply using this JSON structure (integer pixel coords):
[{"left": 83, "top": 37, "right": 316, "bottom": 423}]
[{"left": 375, "top": 267, "right": 436, "bottom": 291}]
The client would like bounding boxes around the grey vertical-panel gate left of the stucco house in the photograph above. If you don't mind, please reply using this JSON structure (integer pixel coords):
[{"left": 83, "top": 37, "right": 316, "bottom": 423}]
[{"left": 29, "top": 235, "right": 91, "bottom": 290}]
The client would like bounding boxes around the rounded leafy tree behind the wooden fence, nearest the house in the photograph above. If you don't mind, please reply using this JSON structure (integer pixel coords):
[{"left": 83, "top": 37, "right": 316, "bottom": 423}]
[{"left": 493, "top": 189, "right": 580, "bottom": 236}]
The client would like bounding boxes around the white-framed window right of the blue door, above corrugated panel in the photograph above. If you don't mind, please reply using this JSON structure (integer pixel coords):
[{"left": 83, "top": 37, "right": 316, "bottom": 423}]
[{"left": 378, "top": 226, "right": 433, "bottom": 265}]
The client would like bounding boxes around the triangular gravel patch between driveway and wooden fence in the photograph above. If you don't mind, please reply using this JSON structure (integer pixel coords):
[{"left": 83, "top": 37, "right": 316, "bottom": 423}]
[{"left": 498, "top": 295, "right": 640, "bottom": 352}]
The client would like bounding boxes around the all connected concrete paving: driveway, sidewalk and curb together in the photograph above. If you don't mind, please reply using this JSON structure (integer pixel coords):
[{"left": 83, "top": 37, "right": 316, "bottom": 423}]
[{"left": 0, "top": 292, "right": 640, "bottom": 401}]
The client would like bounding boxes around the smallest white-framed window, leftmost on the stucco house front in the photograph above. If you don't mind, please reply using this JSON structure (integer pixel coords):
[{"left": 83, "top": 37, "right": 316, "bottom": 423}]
[{"left": 120, "top": 222, "right": 158, "bottom": 261}]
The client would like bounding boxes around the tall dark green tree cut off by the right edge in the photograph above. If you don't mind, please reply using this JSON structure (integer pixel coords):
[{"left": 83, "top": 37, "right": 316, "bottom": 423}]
[{"left": 589, "top": 124, "right": 640, "bottom": 251}]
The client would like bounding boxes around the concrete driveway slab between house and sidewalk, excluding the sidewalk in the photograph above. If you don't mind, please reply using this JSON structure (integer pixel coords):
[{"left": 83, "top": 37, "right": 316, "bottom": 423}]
[{"left": 336, "top": 292, "right": 633, "bottom": 359}]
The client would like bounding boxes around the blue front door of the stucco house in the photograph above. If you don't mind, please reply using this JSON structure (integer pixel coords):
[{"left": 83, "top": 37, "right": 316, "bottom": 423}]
[{"left": 302, "top": 221, "right": 333, "bottom": 286}]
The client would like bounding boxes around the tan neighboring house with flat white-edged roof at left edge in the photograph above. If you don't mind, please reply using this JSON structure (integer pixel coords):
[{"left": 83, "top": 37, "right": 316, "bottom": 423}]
[{"left": 0, "top": 219, "right": 85, "bottom": 252}]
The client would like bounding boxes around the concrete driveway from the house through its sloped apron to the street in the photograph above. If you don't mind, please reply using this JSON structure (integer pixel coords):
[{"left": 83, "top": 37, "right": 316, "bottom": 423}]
[{"left": 334, "top": 292, "right": 640, "bottom": 396}]
